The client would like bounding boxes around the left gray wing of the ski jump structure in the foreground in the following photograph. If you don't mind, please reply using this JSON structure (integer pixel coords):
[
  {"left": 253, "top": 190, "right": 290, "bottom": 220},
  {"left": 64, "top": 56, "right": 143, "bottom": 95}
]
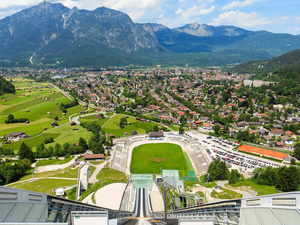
[{"left": 0, "top": 186, "right": 133, "bottom": 224}]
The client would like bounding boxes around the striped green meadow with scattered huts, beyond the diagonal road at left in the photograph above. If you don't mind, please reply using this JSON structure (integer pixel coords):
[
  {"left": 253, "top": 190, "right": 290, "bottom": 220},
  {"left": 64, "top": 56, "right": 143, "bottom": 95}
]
[{"left": 0, "top": 79, "right": 87, "bottom": 136}]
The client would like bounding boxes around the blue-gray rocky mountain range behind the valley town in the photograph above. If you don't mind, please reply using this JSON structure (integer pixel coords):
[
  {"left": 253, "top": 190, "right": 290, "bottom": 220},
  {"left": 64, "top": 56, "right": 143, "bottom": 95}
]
[{"left": 0, "top": 1, "right": 300, "bottom": 67}]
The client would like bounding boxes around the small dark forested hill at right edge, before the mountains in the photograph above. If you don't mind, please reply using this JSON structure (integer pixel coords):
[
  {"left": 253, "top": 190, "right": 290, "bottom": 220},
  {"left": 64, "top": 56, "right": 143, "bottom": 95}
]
[{"left": 233, "top": 49, "right": 300, "bottom": 73}]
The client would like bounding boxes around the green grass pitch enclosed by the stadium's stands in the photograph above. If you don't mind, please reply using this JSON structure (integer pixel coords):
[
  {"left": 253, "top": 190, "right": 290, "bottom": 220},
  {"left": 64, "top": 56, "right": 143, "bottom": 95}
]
[{"left": 130, "top": 143, "right": 189, "bottom": 176}]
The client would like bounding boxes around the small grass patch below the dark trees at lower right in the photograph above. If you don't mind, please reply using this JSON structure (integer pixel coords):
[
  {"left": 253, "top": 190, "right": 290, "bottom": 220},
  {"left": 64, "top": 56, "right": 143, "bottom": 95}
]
[{"left": 225, "top": 181, "right": 277, "bottom": 195}]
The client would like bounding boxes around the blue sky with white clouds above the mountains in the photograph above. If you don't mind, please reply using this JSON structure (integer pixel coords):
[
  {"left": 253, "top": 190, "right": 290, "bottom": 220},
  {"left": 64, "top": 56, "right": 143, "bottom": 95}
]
[{"left": 0, "top": 0, "right": 300, "bottom": 35}]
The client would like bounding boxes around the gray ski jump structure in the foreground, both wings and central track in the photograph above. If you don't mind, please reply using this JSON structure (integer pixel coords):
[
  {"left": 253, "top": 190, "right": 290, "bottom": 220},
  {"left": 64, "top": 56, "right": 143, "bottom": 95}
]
[{"left": 0, "top": 187, "right": 300, "bottom": 225}]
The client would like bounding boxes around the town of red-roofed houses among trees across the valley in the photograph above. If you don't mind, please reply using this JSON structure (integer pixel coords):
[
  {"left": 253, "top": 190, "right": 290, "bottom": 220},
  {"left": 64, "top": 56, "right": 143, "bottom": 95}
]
[{"left": 52, "top": 68, "right": 300, "bottom": 152}]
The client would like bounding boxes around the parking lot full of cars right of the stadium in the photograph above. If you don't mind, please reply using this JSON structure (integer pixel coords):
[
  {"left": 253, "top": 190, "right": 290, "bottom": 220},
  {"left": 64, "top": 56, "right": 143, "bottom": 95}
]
[{"left": 186, "top": 131, "right": 283, "bottom": 175}]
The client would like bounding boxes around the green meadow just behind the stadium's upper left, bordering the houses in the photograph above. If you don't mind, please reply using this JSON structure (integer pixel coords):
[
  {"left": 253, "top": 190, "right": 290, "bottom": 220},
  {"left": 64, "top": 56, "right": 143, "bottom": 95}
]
[{"left": 103, "top": 115, "right": 157, "bottom": 137}]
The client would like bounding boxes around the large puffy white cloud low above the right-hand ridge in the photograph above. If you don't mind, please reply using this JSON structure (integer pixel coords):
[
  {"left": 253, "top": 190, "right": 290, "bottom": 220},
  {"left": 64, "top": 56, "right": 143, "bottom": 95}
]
[{"left": 210, "top": 10, "right": 272, "bottom": 28}]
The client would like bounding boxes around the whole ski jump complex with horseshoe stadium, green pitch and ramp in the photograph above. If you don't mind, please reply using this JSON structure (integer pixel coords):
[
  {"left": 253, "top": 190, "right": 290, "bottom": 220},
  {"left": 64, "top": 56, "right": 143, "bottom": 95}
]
[{"left": 0, "top": 133, "right": 300, "bottom": 225}]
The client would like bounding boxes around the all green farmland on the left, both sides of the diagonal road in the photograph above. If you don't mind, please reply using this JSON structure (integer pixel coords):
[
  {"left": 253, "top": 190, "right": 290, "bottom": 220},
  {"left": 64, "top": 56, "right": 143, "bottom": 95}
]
[{"left": 0, "top": 79, "right": 91, "bottom": 150}]
